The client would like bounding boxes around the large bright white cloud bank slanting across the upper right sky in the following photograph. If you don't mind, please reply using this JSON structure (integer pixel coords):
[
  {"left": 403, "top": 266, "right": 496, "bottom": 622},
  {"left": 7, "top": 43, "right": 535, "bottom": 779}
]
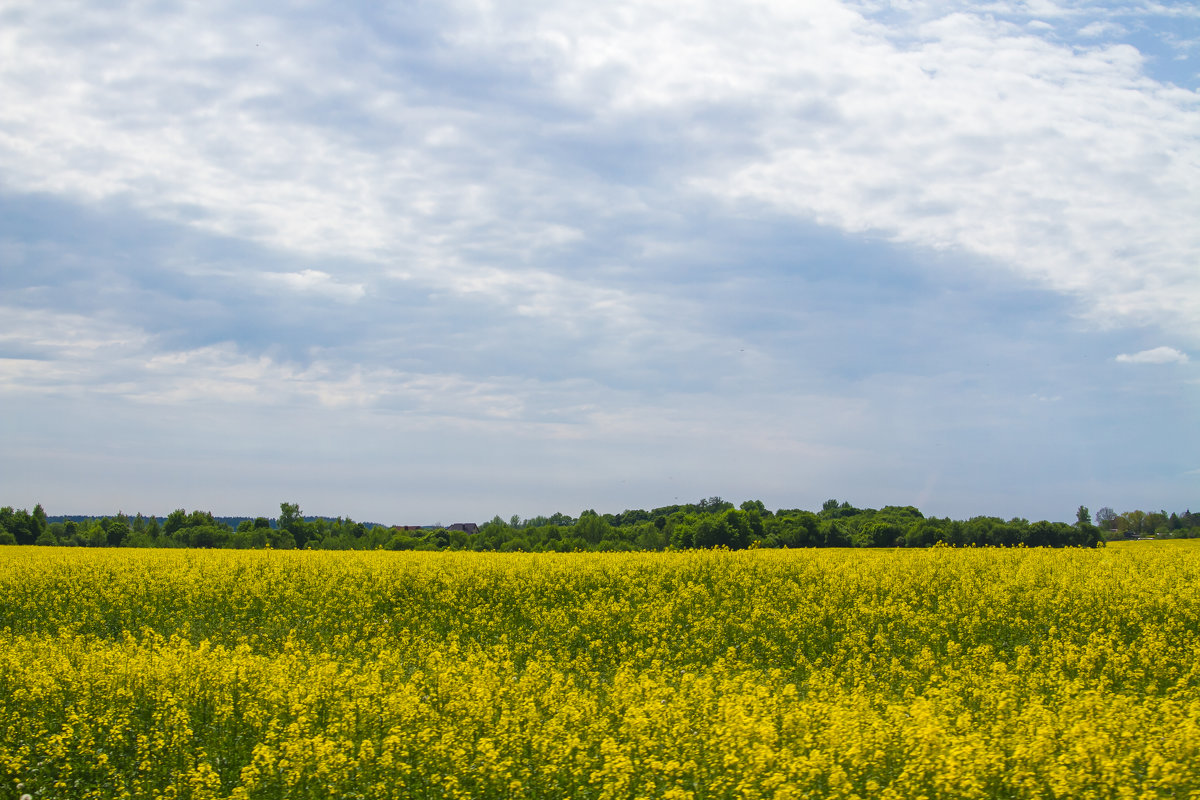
[{"left": 472, "top": 2, "right": 1200, "bottom": 336}]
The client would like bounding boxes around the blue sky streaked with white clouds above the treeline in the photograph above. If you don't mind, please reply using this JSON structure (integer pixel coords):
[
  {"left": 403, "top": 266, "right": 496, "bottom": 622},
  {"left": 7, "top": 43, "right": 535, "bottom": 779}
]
[{"left": 0, "top": 0, "right": 1200, "bottom": 524}]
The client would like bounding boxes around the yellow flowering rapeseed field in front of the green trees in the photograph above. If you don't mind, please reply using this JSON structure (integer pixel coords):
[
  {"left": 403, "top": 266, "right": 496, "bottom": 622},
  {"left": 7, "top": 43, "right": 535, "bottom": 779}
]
[{"left": 0, "top": 542, "right": 1200, "bottom": 799}]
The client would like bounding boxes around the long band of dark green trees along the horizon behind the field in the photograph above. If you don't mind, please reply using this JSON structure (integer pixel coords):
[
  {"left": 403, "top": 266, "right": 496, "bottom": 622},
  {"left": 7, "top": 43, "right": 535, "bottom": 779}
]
[{"left": 0, "top": 497, "right": 1200, "bottom": 552}]
